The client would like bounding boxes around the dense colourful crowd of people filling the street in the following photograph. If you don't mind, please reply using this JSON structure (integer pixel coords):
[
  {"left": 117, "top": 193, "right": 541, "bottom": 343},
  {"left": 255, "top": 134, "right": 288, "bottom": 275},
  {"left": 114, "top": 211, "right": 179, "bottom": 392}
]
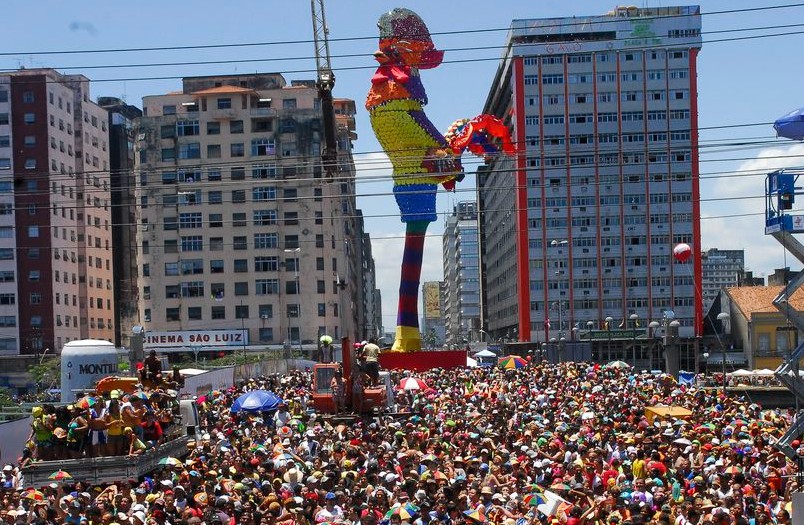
[{"left": 0, "top": 363, "right": 799, "bottom": 525}]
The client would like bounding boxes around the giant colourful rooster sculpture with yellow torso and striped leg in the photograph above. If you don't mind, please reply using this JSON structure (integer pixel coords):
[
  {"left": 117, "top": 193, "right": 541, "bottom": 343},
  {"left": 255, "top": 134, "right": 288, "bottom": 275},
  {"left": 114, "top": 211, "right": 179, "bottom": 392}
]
[{"left": 366, "top": 8, "right": 515, "bottom": 352}]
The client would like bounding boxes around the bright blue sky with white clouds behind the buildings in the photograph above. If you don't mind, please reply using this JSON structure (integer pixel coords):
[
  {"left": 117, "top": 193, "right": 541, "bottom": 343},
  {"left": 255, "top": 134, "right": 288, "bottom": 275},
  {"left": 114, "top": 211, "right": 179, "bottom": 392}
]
[{"left": 0, "top": 0, "right": 804, "bottom": 330}]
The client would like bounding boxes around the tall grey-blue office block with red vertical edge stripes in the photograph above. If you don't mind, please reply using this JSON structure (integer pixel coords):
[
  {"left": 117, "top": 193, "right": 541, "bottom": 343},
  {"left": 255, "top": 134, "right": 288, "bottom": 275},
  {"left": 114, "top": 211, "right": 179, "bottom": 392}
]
[{"left": 479, "top": 6, "right": 702, "bottom": 341}]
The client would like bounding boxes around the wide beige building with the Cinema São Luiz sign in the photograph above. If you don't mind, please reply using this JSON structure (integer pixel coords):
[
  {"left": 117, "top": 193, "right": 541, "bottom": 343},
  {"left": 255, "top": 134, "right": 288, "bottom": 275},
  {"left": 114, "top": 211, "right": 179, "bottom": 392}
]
[{"left": 137, "top": 73, "right": 362, "bottom": 351}]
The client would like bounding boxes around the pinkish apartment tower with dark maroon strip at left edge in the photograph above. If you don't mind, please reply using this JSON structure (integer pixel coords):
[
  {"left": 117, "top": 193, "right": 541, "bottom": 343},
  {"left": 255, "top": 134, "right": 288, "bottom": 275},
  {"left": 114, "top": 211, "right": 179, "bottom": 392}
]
[{"left": 0, "top": 69, "right": 115, "bottom": 354}]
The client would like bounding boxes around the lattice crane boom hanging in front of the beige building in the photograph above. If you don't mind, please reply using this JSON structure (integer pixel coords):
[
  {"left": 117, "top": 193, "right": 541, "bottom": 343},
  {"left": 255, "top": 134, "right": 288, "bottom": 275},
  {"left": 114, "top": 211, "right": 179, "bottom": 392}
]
[{"left": 310, "top": 0, "right": 338, "bottom": 181}]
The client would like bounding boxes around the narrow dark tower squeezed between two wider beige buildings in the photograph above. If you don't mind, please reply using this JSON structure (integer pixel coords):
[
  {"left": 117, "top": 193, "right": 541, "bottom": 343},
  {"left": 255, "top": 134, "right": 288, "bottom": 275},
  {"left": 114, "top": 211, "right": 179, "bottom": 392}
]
[{"left": 98, "top": 97, "right": 142, "bottom": 348}]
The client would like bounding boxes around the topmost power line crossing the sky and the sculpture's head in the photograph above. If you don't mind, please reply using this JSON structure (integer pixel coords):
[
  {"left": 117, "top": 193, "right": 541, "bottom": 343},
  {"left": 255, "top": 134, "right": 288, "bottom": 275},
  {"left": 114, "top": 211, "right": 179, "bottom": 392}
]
[{"left": 0, "top": 3, "right": 804, "bottom": 56}]
